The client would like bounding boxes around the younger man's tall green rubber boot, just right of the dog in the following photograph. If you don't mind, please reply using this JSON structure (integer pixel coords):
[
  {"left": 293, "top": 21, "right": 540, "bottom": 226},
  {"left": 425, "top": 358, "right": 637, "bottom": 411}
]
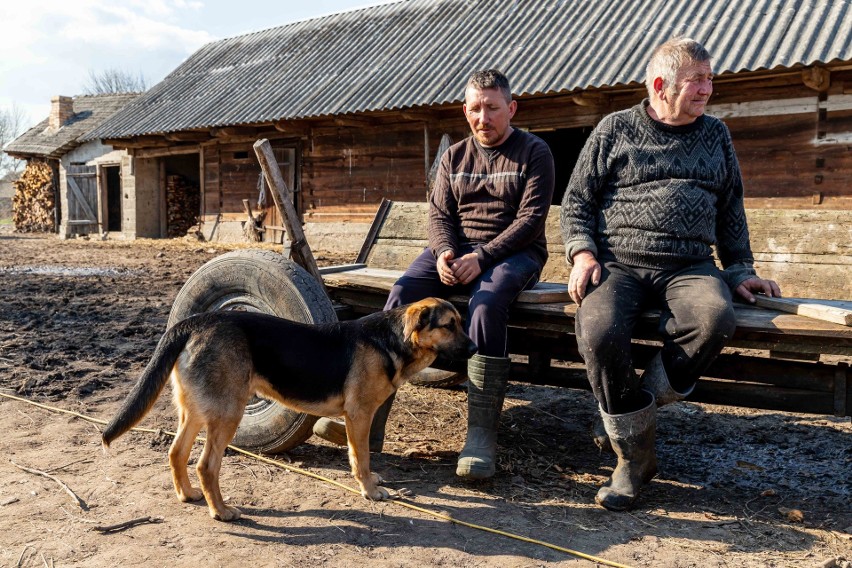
[{"left": 456, "top": 355, "right": 510, "bottom": 479}]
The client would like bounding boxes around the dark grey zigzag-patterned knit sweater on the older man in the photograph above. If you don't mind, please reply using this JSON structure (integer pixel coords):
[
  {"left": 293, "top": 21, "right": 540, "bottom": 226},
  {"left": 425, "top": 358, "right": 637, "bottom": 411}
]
[{"left": 560, "top": 99, "right": 755, "bottom": 289}]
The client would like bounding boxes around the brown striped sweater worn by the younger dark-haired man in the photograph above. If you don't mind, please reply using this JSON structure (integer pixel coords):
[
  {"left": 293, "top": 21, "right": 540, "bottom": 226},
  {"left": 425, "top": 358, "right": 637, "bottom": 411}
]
[{"left": 428, "top": 129, "right": 555, "bottom": 270}]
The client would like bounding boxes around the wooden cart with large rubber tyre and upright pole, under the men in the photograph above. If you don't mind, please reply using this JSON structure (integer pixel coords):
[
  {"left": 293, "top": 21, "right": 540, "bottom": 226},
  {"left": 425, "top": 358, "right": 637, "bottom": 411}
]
[{"left": 169, "top": 140, "right": 852, "bottom": 453}]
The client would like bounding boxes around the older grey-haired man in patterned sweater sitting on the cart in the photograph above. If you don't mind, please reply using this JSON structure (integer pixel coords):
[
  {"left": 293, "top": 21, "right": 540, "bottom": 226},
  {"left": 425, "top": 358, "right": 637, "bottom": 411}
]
[{"left": 561, "top": 38, "right": 780, "bottom": 510}]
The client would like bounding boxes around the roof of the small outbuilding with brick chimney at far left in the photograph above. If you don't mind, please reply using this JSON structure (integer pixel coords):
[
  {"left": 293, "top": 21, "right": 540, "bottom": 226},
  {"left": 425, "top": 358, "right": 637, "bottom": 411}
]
[{"left": 3, "top": 93, "right": 139, "bottom": 159}]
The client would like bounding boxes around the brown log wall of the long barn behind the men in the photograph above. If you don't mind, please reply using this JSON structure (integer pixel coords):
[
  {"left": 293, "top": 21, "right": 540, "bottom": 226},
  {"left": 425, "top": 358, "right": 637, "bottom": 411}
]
[{"left": 181, "top": 70, "right": 852, "bottom": 248}]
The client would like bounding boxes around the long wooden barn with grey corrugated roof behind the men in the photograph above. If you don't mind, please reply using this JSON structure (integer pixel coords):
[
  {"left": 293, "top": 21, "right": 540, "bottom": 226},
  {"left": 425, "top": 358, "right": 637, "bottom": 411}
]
[{"left": 78, "top": 0, "right": 852, "bottom": 299}]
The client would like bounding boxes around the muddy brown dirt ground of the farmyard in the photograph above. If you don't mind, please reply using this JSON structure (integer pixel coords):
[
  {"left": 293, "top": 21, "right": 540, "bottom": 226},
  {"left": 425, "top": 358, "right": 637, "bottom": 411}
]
[{"left": 0, "top": 227, "right": 852, "bottom": 568}]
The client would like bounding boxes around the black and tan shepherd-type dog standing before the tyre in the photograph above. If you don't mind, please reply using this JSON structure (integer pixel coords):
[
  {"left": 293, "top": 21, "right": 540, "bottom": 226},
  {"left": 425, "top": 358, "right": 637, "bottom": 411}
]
[{"left": 103, "top": 298, "right": 476, "bottom": 521}]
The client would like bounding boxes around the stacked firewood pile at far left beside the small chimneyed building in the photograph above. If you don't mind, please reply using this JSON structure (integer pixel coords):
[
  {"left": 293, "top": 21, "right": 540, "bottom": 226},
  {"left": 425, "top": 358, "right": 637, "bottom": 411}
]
[{"left": 12, "top": 162, "right": 56, "bottom": 233}]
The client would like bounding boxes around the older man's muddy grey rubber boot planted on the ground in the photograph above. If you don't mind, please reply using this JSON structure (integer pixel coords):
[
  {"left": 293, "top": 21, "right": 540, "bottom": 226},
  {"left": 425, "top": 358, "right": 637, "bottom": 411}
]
[{"left": 595, "top": 390, "right": 657, "bottom": 511}]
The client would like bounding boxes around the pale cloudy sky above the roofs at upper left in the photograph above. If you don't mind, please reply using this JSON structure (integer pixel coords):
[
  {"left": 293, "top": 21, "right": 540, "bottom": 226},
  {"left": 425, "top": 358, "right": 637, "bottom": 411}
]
[{"left": 0, "top": 0, "right": 390, "bottom": 132}]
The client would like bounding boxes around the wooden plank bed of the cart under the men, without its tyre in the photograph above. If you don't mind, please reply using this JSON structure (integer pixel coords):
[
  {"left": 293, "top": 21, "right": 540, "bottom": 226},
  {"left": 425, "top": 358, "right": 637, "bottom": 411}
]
[{"left": 320, "top": 197, "right": 852, "bottom": 416}]
